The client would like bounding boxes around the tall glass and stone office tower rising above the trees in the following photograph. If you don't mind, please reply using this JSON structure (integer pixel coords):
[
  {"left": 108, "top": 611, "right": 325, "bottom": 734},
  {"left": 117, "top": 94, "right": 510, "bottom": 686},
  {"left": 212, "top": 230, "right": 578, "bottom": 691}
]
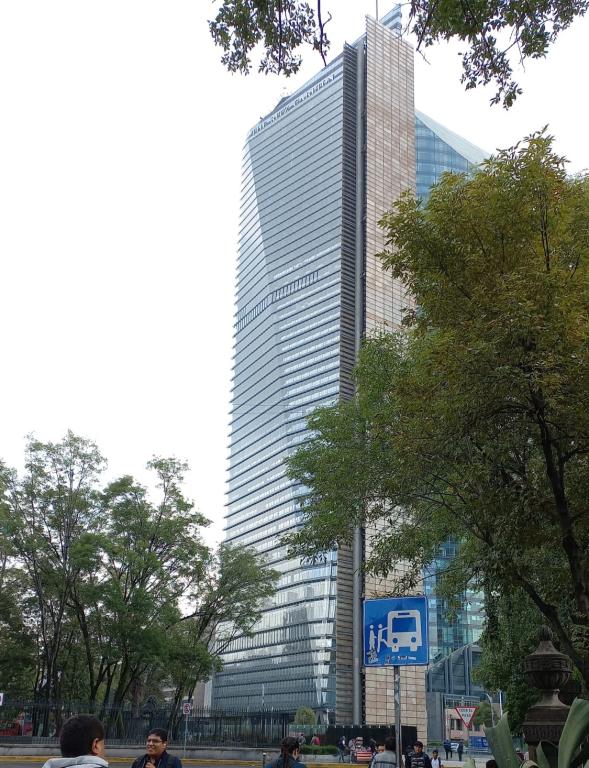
[{"left": 213, "top": 8, "right": 482, "bottom": 734}]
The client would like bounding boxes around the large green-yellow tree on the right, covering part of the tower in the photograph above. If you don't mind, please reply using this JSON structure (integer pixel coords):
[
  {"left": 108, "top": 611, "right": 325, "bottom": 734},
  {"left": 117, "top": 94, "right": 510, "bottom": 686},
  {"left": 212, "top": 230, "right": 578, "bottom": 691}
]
[{"left": 290, "top": 134, "right": 589, "bottom": 685}]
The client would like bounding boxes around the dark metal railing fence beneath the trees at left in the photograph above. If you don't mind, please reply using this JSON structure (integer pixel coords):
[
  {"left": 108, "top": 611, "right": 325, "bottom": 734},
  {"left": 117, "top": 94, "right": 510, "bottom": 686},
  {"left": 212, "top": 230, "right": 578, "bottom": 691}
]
[{"left": 0, "top": 699, "right": 292, "bottom": 747}]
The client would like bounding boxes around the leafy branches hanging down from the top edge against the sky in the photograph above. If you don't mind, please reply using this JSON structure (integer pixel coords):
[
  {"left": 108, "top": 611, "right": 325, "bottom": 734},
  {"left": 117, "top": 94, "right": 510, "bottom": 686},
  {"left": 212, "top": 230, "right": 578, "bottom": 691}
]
[{"left": 209, "top": 0, "right": 588, "bottom": 107}]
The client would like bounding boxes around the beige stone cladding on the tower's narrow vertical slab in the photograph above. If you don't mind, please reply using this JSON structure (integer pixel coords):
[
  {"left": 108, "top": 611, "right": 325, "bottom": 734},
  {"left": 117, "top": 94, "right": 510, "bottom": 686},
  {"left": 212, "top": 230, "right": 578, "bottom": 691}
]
[{"left": 364, "top": 17, "right": 427, "bottom": 740}]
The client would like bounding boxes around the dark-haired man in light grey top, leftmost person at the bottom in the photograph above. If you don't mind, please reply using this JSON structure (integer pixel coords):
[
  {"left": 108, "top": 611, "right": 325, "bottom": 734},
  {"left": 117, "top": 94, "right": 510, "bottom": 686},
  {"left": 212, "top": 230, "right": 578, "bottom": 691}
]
[{"left": 43, "top": 715, "right": 108, "bottom": 768}]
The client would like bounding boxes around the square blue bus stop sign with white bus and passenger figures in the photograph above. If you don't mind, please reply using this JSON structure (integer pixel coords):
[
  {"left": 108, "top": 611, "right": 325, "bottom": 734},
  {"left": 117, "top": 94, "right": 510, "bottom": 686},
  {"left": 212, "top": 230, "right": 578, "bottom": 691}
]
[{"left": 364, "top": 595, "right": 429, "bottom": 667}]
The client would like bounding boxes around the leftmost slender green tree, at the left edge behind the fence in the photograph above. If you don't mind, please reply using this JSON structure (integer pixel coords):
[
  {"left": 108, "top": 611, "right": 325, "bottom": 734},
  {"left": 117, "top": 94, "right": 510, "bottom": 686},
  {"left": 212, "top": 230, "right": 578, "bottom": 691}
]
[{"left": 1, "top": 432, "right": 104, "bottom": 735}]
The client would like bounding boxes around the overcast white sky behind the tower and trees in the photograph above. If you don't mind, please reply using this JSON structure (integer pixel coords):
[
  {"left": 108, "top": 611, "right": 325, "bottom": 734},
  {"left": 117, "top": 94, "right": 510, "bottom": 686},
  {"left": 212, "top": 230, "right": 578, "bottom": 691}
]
[{"left": 0, "top": 0, "right": 589, "bottom": 536}]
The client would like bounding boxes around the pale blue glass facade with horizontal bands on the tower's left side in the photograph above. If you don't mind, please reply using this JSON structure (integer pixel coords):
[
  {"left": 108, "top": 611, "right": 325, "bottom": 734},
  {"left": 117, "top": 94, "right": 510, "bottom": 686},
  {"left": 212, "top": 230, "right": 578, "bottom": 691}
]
[{"left": 213, "top": 52, "right": 355, "bottom": 709}]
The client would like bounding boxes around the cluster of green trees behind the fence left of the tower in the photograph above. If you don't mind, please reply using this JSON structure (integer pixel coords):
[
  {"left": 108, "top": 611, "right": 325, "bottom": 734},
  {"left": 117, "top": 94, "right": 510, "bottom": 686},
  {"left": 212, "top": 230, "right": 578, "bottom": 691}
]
[{"left": 0, "top": 432, "right": 276, "bottom": 730}]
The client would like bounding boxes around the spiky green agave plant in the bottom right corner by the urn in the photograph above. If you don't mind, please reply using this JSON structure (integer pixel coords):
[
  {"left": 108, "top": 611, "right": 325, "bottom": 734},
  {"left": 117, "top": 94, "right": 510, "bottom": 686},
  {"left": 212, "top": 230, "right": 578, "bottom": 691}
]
[{"left": 485, "top": 699, "right": 589, "bottom": 768}]
